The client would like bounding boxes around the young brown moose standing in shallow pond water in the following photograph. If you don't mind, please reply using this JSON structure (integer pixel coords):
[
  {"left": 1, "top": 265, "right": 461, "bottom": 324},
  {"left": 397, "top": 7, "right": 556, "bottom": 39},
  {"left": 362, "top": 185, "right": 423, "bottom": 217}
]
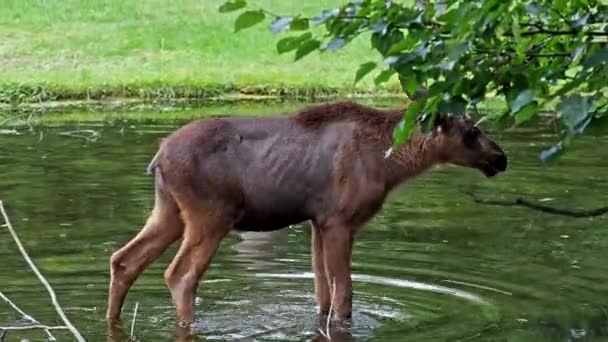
[{"left": 107, "top": 102, "right": 507, "bottom": 323}]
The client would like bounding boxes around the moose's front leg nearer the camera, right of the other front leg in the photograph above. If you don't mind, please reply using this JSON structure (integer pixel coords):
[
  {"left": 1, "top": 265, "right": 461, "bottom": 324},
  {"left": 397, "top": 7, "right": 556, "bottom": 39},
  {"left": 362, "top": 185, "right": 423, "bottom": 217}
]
[{"left": 322, "top": 223, "right": 354, "bottom": 320}]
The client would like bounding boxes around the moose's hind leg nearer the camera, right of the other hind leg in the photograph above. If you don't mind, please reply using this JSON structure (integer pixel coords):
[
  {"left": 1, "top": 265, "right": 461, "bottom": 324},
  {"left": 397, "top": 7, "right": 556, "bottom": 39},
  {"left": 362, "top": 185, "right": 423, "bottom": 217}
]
[{"left": 165, "top": 210, "right": 232, "bottom": 324}]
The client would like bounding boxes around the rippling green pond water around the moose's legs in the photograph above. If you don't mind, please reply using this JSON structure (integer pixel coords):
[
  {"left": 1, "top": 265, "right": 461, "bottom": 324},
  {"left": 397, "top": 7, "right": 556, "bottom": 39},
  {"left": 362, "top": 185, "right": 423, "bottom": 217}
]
[{"left": 0, "top": 104, "right": 608, "bottom": 341}]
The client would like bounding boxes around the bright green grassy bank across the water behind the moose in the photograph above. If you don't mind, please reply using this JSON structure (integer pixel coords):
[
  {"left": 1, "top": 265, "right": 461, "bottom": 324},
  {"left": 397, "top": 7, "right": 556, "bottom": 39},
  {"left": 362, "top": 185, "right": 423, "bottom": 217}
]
[{"left": 0, "top": 0, "right": 402, "bottom": 103}]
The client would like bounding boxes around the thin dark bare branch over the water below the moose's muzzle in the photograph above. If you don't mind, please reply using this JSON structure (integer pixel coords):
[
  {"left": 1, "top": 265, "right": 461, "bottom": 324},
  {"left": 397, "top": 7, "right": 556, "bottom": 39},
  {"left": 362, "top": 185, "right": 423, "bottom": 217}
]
[{"left": 465, "top": 191, "right": 608, "bottom": 218}]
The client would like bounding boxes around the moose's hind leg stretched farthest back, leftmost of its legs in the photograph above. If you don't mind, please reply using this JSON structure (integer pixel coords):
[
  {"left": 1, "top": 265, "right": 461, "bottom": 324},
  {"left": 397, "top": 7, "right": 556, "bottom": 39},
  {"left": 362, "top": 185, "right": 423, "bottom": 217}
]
[{"left": 106, "top": 190, "right": 184, "bottom": 321}]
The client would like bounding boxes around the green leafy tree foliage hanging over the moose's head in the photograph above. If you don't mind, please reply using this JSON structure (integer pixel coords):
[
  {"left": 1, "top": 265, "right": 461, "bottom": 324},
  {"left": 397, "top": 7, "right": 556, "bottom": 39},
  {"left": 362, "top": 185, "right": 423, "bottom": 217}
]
[{"left": 221, "top": 0, "right": 608, "bottom": 160}]
